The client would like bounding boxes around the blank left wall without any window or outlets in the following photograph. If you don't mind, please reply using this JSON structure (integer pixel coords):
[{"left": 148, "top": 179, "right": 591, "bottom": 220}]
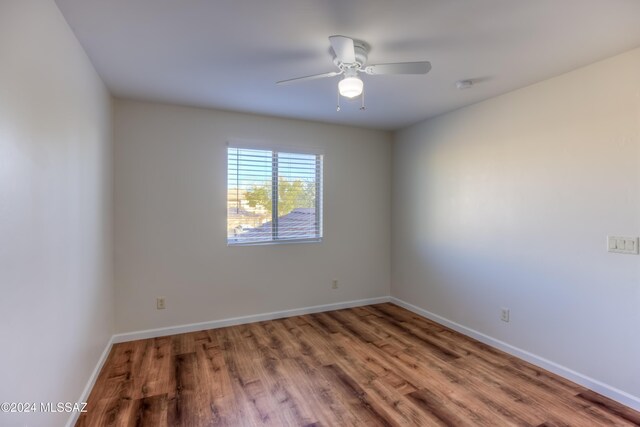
[{"left": 0, "top": 0, "right": 114, "bottom": 426}]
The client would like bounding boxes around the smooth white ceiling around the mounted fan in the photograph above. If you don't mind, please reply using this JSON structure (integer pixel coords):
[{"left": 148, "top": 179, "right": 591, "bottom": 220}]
[{"left": 57, "top": 0, "right": 640, "bottom": 129}]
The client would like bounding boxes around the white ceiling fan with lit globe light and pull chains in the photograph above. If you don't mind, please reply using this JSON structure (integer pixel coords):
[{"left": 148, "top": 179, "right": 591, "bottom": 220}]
[{"left": 276, "top": 36, "right": 431, "bottom": 110}]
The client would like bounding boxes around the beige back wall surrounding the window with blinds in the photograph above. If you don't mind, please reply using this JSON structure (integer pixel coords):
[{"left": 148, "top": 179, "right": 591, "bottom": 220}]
[{"left": 115, "top": 100, "right": 391, "bottom": 332}]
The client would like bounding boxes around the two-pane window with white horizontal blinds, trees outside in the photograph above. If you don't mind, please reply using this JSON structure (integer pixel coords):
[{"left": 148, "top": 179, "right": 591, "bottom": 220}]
[{"left": 227, "top": 147, "right": 322, "bottom": 245}]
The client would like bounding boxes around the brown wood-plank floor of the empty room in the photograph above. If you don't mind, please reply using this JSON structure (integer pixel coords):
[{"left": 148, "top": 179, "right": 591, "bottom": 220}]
[{"left": 77, "top": 304, "right": 640, "bottom": 426}]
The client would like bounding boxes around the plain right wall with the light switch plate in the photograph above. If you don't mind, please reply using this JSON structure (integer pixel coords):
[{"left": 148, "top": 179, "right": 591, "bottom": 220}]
[{"left": 391, "top": 50, "right": 640, "bottom": 406}]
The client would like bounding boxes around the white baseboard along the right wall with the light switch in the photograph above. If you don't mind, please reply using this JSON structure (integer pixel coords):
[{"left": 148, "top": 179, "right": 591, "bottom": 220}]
[{"left": 389, "top": 297, "right": 640, "bottom": 411}]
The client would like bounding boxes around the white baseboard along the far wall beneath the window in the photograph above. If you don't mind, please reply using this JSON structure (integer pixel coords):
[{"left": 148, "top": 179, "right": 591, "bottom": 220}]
[{"left": 112, "top": 297, "right": 389, "bottom": 343}]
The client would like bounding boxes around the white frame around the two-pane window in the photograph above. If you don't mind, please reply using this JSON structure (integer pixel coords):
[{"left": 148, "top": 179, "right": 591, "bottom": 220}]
[{"left": 225, "top": 141, "right": 324, "bottom": 246}]
